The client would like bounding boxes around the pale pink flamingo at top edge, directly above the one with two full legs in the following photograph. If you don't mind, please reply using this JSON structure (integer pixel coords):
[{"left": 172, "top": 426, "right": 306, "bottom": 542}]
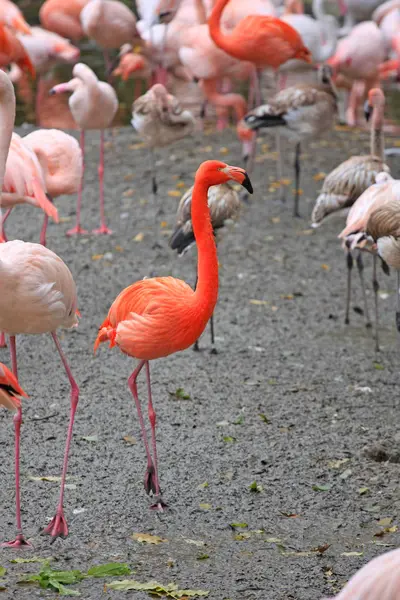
[{"left": 80, "top": 0, "right": 137, "bottom": 73}]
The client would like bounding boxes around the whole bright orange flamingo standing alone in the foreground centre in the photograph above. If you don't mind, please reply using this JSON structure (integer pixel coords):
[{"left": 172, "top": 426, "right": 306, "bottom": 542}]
[{"left": 94, "top": 160, "right": 253, "bottom": 510}]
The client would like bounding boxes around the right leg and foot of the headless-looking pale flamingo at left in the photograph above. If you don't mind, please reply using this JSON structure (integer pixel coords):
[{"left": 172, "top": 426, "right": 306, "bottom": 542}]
[{"left": 42, "top": 331, "right": 79, "bottom": 543}]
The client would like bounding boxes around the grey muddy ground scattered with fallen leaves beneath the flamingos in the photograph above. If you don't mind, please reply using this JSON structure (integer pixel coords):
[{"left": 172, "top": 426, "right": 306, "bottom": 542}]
[{"left": 0, "top": 123, "right": 400, "bottom": 600}]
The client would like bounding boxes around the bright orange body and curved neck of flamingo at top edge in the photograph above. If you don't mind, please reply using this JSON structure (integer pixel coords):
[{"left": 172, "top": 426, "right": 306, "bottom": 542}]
[{"left": 208, "top": 0, "right": 311, "bottom": 69}]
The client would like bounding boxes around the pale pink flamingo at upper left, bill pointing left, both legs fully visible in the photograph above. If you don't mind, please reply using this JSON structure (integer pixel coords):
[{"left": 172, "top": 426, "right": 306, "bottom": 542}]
[{"left": 50, "top": 63, "right": 118, "bottom": 235}]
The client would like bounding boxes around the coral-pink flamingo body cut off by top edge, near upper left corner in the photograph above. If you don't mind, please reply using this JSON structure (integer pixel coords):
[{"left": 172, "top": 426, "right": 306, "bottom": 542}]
[{"left": 39, "top": 0, "right": 90, "bottom": 42}]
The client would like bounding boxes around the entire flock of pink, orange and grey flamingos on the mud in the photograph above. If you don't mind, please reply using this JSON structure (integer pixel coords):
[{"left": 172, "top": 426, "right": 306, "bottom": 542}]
[{"left": 0, "top": 0, "right": 400, "bottom": 600}]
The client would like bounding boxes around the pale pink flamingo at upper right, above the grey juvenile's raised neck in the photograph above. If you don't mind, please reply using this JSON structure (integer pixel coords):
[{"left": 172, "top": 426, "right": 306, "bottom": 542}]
[{"left": 328, "top": 21, "right": 385, "bottom": 126}]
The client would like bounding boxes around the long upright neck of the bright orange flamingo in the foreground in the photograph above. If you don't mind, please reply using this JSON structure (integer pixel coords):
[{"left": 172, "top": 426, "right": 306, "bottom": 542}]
[{"left": 192, "top": 175, "right": 218, "bottom": 320}]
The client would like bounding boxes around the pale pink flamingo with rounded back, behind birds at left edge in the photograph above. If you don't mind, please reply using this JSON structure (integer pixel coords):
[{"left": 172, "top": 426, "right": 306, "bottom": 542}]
[{"left": 23, "top": 129, "right": 83, "bottom": 246}]
